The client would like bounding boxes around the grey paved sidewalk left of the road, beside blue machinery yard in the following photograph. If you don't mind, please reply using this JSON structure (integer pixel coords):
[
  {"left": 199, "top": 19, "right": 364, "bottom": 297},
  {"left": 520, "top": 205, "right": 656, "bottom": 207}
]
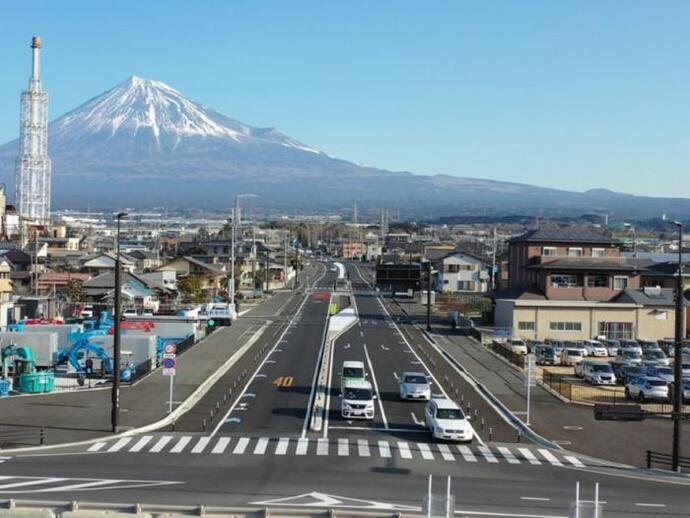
[{"left": 0, "top": 272, "right": 314, "bottom": 448}]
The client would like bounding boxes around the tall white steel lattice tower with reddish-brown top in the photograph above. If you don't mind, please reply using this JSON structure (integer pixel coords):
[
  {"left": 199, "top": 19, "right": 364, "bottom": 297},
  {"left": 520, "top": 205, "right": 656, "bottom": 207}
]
[{"left": 15, "top": 37, "right": 51, "bottom": 223}]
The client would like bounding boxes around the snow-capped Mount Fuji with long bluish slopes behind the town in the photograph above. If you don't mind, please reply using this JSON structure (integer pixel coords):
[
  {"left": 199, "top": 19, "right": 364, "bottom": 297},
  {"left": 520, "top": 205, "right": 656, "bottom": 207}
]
[{"left": 0, "top": 76, "right": 690, "bottom": 216}]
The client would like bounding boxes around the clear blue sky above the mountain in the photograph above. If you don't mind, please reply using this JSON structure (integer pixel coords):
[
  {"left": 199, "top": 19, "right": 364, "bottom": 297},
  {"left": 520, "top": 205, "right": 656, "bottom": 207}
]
[{"left": 0, "top": 0, "right": 690, "bottom": 197}]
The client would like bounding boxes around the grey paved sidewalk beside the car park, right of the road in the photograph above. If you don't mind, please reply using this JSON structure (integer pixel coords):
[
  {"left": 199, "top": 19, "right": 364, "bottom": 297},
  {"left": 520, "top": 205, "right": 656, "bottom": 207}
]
[{"left": 396, "top": 299, "right": 690, "bottom": 472}]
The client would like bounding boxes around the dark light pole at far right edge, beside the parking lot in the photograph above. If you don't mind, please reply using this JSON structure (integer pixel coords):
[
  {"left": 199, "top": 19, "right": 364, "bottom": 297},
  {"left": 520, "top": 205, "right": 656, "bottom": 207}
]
[{"left": 671, "top": 221, "right": 684, "bottom": 471}]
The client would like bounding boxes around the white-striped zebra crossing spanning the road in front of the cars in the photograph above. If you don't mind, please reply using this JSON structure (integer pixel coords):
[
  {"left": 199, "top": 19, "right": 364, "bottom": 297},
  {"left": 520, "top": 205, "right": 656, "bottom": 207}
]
[{"left": 87, "top": 434, "right": 585, "bottom": 468}]
